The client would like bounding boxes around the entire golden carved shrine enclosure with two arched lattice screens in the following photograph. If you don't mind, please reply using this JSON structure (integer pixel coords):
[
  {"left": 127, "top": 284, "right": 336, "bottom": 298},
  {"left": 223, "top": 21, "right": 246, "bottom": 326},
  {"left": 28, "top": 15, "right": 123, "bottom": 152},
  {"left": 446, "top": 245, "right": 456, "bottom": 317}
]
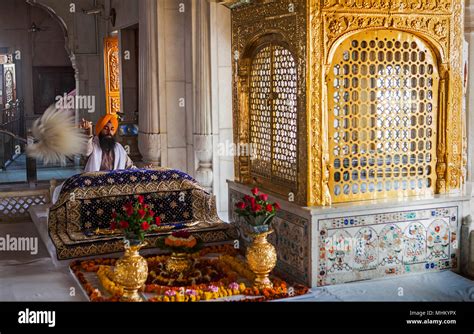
[{"left": 228, "top": 0, "right": 466, "bottom": 206}]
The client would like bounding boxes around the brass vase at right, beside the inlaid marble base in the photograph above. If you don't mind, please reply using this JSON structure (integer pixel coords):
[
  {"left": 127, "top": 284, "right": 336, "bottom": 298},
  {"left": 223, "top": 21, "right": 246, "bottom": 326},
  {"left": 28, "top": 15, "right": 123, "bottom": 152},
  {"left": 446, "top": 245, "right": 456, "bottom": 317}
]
[{"left": 245, "top": 230, "right": 277, "bottom": 289}]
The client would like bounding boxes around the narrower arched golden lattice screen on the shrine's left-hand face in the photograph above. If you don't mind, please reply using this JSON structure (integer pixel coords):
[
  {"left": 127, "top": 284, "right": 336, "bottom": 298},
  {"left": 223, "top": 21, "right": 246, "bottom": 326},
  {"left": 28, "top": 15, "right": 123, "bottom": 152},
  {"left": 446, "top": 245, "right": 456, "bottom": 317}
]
[{"left": 249, "top": 44, "right": 297, "bottom": 185}]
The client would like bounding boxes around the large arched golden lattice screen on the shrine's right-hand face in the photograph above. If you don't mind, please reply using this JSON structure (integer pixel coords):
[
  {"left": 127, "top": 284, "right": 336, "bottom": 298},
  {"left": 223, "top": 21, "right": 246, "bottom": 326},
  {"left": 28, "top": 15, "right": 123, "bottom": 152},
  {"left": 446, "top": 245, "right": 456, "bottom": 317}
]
[{"left": 327, "top": 30, "right": 439, "bottom": 202}]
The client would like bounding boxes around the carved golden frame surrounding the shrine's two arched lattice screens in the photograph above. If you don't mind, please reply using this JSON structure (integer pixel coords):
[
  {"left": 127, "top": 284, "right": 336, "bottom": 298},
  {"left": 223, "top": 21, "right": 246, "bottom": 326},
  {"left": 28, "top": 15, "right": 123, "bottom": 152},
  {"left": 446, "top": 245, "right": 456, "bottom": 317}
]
[{"left": 232, "top": 0, "right": 465, "bottom": 206}]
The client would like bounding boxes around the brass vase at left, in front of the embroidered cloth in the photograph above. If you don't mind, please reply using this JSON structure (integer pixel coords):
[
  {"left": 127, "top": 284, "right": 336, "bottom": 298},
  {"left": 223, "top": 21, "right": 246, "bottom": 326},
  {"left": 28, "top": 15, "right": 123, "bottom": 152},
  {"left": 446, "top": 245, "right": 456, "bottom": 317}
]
[{"left": 113, "top": 242, "right": 148, "bottom": 302}]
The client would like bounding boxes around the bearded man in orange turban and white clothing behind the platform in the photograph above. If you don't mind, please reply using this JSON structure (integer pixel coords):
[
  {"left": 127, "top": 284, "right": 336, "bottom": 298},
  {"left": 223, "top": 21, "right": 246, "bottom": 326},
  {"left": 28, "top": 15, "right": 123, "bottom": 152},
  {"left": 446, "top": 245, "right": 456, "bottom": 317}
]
[{"left": 81, "top": 114, "right": 136, "bottom": 172}]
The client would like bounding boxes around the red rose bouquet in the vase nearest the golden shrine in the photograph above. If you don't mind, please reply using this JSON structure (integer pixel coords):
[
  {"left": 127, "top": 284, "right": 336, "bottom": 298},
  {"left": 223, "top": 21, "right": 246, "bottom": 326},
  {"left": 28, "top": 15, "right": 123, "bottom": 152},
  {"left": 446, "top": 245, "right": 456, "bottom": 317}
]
[{"left": 235, "top": 188, "right": 280, "bottom": 233}]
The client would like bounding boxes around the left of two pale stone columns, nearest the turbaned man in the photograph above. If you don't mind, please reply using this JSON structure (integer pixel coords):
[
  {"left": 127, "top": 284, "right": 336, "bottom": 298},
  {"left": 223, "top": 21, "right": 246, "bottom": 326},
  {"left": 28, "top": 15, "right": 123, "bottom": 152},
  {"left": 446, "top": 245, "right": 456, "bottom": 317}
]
[{"left": 138, "top": 0, "right": 162, "bottom": 166}]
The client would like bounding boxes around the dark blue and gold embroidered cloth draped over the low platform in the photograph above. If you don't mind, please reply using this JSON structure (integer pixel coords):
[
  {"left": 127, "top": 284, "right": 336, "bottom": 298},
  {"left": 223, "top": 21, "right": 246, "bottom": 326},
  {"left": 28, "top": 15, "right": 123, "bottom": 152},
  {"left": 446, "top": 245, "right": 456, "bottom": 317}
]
[{"left": 48, "top": 169, "right": 235, "bottom": 259}]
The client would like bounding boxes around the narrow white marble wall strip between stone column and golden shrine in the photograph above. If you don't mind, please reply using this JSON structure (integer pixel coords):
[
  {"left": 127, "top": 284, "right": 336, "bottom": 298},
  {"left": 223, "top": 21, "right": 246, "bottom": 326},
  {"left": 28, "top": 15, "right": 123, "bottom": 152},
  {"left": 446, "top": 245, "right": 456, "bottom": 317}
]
[{"left": 210, "top": 3, "right": 234, "bottom": 221}]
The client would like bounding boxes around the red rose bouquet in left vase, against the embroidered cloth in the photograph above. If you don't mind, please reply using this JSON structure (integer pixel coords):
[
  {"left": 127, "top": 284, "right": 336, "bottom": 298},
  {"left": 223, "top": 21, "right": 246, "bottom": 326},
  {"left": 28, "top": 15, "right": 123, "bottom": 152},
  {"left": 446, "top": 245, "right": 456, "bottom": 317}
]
[{"left": 110, "top": 195, "right": 161, "bottom": 245}]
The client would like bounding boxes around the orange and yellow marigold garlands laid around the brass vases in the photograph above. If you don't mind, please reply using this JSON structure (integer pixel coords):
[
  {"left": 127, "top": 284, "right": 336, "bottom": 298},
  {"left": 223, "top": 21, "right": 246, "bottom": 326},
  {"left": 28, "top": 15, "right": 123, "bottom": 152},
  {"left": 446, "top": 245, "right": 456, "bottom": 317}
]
[{"left": 70, "top": 244, "right": 309, "bottom": 302}]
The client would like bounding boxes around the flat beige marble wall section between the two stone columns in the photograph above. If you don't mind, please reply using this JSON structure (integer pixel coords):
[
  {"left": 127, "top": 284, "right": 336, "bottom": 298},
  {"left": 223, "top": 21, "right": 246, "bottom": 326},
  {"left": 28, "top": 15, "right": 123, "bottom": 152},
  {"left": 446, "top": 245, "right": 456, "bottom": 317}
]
[{"left": 158, "top": 0, "right": 194, "bottom": 175}]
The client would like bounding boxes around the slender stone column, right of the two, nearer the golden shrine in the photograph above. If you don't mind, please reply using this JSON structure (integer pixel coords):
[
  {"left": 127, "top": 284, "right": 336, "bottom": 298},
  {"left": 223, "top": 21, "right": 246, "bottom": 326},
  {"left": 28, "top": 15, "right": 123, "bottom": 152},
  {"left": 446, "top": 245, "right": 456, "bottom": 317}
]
[{"left": 193, "top": 0, "right": 213, "bottom": 192}]
